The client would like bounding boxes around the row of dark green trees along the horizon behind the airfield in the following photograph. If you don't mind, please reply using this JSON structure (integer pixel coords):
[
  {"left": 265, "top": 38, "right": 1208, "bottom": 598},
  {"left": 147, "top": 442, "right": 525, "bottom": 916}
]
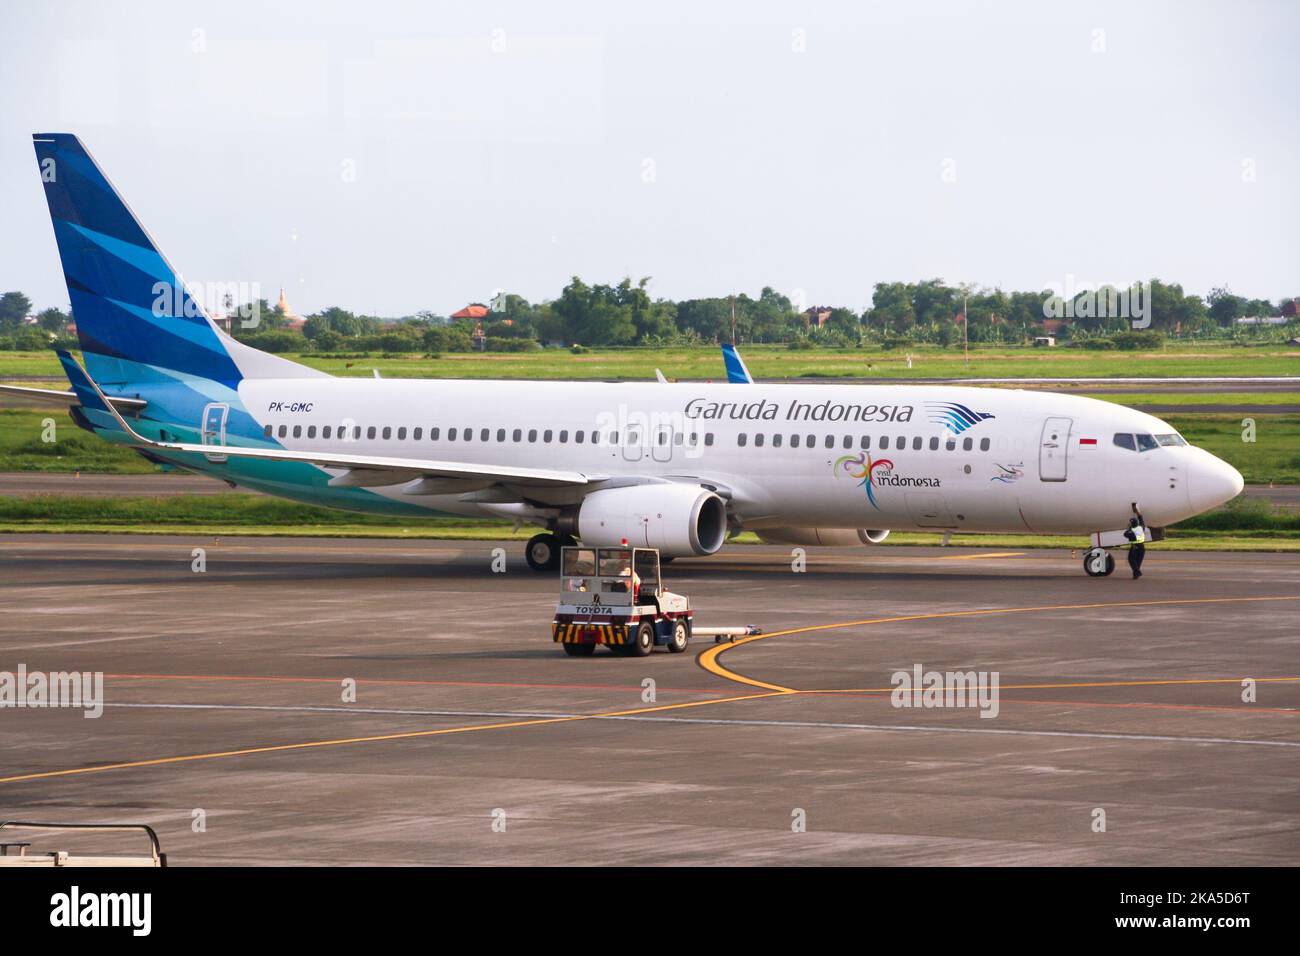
[{"left": 0, "top": 276, "right": 1296, "bottom": 352}]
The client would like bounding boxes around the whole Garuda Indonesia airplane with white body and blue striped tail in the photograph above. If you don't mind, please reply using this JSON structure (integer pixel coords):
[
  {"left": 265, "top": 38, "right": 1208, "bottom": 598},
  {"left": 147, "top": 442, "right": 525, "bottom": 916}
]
[{"left": 7, "top": 133, "right": 1243, "bottom": 576}]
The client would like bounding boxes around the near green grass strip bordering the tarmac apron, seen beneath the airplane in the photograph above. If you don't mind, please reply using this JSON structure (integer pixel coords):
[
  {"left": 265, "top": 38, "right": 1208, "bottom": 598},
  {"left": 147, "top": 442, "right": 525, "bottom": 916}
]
[{"left": 0, "top": 492, "right": 1300, "bottom": 551}]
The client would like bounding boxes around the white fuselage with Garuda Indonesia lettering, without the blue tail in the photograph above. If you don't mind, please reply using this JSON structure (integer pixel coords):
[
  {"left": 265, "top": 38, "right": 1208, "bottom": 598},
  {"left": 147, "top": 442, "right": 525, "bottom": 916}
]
[{"left": 218, "top": 378, "right": 1240, "bottom": 533}]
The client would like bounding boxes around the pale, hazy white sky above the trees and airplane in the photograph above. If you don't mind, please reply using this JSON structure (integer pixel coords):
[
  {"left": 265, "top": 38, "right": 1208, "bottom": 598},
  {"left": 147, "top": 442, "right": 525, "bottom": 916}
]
[{"left": 0, "top": 0, "right": 1300, "bottom": 316}]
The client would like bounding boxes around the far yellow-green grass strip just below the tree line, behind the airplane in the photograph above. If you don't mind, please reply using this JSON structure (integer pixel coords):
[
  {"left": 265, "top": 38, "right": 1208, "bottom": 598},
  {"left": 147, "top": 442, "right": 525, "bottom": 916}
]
[{"left": 0, "top": 342, "right": 1300, "bottom": 380}]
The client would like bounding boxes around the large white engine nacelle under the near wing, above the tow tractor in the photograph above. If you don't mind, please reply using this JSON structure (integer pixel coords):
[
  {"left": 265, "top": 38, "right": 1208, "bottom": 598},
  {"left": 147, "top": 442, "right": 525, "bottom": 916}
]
[{"left": 577, "top": 483, "right": 727, "bottom": 558}]
